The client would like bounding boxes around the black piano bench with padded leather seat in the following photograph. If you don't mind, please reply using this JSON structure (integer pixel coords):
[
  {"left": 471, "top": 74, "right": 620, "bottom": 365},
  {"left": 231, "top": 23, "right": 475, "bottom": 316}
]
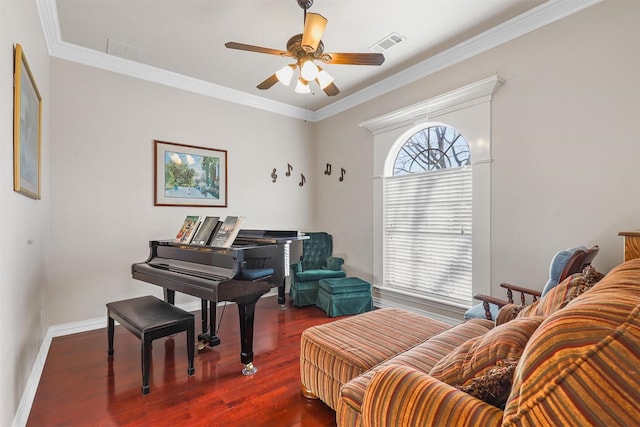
[{"left": 107, "top": 295, "right": 195, "bottom": 395}]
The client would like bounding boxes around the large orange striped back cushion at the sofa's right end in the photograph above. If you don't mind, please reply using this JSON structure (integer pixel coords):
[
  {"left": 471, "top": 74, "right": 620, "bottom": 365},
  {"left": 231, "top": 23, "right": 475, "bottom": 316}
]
[{"left": 504, "top": 260, "right": 640, "bottom": 426}]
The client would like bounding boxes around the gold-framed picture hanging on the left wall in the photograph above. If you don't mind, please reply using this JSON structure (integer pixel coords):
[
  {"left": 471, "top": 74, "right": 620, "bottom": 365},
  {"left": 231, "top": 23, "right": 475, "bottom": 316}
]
[{"left": 13, "top": 44, "right": 42, "bottom": 200}]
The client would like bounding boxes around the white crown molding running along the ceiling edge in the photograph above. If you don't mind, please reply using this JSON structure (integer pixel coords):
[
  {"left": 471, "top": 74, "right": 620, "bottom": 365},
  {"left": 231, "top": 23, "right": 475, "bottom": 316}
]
[{"left": 36, "top": 0, "right": 603, "bottom": 122}]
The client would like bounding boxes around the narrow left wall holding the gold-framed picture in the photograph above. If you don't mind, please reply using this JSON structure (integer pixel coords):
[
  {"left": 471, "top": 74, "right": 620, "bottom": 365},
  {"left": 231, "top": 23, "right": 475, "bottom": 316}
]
[{"left": 0, "top": 1, "right": 51, "bottom": 426}]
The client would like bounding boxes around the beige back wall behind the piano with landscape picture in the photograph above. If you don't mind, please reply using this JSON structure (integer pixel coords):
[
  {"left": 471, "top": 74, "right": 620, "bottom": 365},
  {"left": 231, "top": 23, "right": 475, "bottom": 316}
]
[{"left": 46, "top": 59, "right": 314, "bottom": 325}]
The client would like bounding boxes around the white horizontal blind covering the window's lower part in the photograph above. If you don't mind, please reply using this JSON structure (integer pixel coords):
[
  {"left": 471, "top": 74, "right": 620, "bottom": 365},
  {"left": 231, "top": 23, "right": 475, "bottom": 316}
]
[{"left": 384, "top": 166, "right": 472, "bottom": 307}]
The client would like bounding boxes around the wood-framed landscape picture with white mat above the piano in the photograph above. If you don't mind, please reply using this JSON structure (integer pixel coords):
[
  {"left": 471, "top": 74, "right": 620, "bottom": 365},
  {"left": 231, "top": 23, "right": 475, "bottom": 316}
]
[{"left": 154, "top": 140, "right": 227, "bottom": 208}]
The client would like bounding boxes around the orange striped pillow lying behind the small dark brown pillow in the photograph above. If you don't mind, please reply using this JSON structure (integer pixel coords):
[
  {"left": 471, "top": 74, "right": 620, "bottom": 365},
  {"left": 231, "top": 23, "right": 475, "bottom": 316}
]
[{"left": 429, "top": 316, "right": 545, "bottom": 387}]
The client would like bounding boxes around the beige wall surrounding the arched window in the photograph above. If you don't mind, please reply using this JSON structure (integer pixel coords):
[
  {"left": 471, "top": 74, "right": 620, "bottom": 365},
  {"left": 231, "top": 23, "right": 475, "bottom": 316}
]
[{"left": 316, "top": 1, "right": 640, "bottom": 295}]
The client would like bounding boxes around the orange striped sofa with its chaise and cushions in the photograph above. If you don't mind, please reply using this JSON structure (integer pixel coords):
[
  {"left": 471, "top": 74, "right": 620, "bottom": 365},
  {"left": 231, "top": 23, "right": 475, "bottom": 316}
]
[{"left": 301, "top": 259, "right": 640, "bottom": 427}]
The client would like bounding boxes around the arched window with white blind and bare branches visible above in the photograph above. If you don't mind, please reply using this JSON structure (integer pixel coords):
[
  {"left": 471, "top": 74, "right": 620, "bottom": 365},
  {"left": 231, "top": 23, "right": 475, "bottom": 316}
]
[{"left": 384, "top": 125, "right": 472, "bottom": 305}]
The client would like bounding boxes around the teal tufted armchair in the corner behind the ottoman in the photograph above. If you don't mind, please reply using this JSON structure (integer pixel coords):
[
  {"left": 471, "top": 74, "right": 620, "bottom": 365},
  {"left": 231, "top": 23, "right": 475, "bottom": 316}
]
[{"left": 289, "top": 232, "right": 347, "bottom": 307}]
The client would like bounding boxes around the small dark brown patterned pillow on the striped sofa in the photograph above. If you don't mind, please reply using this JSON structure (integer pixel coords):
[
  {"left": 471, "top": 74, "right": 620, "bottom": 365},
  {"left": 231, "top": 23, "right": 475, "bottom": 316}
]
[{"left": 456, "top": 359, "right": 518, "bottom": 409}]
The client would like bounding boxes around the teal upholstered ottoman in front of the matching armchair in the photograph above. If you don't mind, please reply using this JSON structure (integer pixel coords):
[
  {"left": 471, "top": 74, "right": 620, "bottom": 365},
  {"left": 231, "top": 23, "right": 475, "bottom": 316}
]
[{"left": 316, "top": 277, "right": 373, "bottom": 317}]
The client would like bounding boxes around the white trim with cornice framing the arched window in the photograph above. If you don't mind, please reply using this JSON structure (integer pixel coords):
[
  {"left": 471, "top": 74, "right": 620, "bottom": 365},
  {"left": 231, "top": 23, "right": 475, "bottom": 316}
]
[{"left": 360, "top": 75, "right": 503, "bottom": 318}]
